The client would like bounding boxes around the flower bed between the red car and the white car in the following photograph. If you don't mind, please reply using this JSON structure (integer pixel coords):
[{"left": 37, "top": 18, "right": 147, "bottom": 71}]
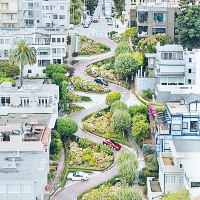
[{"left": 69, "top": 142, "right": 114, "bottom": 170}]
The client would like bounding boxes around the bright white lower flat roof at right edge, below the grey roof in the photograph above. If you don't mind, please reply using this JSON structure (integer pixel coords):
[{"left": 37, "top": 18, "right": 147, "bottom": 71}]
[{"left": 181, "top": 159, "right": 200, "bottom": 178}]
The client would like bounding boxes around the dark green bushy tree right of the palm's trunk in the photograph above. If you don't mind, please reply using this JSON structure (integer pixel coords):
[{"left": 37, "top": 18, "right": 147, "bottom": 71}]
[{"left": 43, "top": 64, "right": 68, "bottom": 78}]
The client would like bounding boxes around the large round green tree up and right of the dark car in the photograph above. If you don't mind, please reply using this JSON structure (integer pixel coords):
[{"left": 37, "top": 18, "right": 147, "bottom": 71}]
[{"left": 115, "top": 52, "right": 138, "bottom": 80}]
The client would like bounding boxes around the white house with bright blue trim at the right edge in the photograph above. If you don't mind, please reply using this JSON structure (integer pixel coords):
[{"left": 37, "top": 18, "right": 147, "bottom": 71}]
[{"left": 154, "top": 93, "right": 200, "bottom": 152}]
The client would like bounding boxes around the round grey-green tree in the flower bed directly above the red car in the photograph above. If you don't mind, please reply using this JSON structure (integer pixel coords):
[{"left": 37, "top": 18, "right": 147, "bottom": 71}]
[{"left": 111, "top": 110, "right": 131, "bottom": 134}]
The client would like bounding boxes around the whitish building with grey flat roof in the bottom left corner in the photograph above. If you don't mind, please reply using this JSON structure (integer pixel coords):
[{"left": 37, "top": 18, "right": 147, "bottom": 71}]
[{"left": 0, "top": 152, "right": 48, "bottom": 200}]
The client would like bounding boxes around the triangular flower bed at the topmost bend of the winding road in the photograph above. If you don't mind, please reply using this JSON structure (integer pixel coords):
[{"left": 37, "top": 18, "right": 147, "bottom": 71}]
[{"left": 79, "top": 36, "right": 110, "bottom": 55}]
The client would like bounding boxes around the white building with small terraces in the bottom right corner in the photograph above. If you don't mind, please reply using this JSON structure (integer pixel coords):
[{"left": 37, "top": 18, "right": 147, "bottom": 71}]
[{"left": 147, "top": 140, "right": 200, "bottom": 200}]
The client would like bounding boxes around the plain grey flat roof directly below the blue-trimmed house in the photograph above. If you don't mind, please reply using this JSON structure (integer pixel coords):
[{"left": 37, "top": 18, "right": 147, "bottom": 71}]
[{"left": 173, "top": 140, "right": 200, "bottom": 153}]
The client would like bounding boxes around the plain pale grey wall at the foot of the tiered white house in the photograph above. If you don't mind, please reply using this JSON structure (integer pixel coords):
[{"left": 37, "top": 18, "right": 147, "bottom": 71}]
[{"left": 135, "top": 77, "right": 158, "bottom": 94}]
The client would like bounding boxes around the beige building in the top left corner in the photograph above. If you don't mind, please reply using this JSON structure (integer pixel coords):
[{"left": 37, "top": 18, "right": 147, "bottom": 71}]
[{"left": 0, "top": 0, "right": 18, "bottom": 27}]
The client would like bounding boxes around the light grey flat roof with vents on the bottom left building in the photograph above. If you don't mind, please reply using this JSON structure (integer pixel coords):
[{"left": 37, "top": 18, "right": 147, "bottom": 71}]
[{"left": 0, "top": 152, "right": 47, "bottom": 180}]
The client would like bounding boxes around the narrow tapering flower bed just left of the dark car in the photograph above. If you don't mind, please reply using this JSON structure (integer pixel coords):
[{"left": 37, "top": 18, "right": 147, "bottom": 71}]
[{"left": 71, "top": 76, "right": 110, "bottom": 93}]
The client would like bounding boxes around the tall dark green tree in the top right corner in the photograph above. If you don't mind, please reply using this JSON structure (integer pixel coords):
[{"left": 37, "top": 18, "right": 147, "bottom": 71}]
[{"left": 177, "top": 0, "right": 200, "bottom": 50}]
